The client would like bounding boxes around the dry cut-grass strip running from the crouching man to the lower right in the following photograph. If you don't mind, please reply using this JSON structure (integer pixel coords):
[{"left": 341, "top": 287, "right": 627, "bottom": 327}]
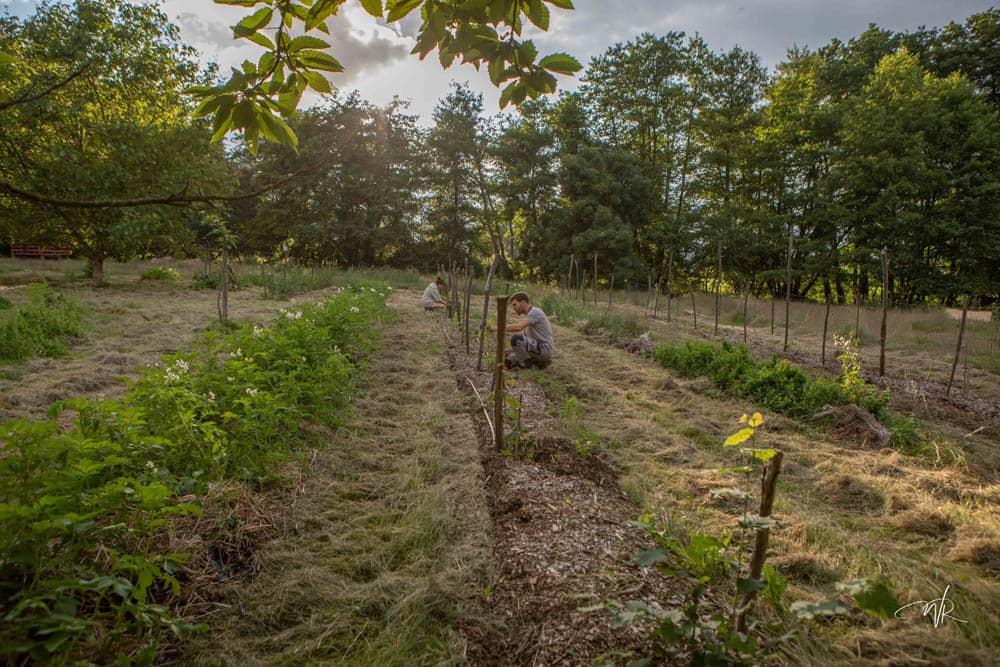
[{"left": 539, "top": 316, "right": 1000, "bottom": 664}]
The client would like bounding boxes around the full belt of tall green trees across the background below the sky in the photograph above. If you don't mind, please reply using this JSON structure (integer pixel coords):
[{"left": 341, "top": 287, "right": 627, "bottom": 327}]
[{"left": 0, "top": 0, "right": 1000, "bottom": 304}]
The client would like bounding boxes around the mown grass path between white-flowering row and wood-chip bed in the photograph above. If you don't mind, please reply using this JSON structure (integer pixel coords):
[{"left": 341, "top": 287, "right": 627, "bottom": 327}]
[{"left": 184, "top": 292, "right": 490, "bottom": 665}]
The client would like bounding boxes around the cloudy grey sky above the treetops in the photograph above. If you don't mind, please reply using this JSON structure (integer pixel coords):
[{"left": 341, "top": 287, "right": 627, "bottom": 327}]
[{"left": 0, "top": 0, "right": 993, "bottom": 125}]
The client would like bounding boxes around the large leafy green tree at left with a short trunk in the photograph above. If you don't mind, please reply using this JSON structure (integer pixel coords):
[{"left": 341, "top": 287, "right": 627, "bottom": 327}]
[{"left": 0, "top": 0, "right": 226, "bottom": 285}]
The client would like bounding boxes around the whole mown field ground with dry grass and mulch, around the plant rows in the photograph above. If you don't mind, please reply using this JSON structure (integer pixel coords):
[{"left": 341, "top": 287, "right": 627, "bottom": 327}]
[{"left": 0, "top": 260, "right": 1000, "bottom": 665}]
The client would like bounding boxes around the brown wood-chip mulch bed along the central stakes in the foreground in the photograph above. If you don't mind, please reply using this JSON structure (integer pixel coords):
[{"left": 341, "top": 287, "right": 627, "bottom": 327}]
[{"left": 451, "top": 348, "right": 682, "bottom": 665}]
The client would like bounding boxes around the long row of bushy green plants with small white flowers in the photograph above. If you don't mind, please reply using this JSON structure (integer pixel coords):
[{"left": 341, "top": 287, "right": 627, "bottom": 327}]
[{"left": 0, "top": 285, "right": 388, "bottom": 663}]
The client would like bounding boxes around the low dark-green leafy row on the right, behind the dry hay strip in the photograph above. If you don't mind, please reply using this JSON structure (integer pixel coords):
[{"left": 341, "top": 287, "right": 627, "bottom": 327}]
[{"left": 653, "top": 342, "right": 889, "bottom": 418}]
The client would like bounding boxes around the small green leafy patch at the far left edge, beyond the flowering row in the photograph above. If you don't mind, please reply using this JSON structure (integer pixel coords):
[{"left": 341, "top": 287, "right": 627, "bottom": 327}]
[{"left": 0, "top": 283, "right": 83, "bottom": 361}]
